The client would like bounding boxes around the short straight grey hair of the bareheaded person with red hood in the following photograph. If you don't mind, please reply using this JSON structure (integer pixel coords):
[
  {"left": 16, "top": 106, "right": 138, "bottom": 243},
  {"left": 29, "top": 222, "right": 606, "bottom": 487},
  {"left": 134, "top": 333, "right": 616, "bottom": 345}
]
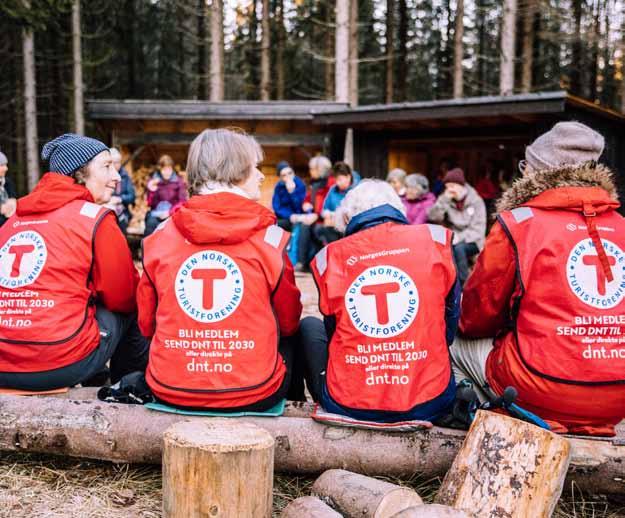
[{"left": 187, "top": 128, "right": 263, "bottom": 196}]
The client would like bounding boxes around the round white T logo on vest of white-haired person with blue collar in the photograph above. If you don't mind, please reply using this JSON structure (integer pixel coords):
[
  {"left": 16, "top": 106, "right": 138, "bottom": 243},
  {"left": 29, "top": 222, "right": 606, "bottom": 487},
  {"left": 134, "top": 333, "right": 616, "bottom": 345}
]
[{"left": 345, "top": 265, "right": 419, "bottom": 338}]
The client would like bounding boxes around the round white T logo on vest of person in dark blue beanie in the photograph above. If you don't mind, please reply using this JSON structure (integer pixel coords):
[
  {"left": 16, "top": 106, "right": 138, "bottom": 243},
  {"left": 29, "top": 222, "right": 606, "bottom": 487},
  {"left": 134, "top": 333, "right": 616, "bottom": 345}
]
[{"left": 0, "top": 230, "right": 48, "bottom": 288}]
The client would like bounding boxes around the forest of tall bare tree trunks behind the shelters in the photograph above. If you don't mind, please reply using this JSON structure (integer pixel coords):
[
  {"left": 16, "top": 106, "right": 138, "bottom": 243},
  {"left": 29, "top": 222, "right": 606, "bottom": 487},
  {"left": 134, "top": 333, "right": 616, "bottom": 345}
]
[{"left": 0, "top": 0, "right": 625, "bottom": 193}]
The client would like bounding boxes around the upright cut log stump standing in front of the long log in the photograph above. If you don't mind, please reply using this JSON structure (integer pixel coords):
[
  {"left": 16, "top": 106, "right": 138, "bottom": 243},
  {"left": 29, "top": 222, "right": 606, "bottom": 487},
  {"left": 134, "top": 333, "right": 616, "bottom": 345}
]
[{"left": 163, "top": 419, "right": 274, "bottom": 518}]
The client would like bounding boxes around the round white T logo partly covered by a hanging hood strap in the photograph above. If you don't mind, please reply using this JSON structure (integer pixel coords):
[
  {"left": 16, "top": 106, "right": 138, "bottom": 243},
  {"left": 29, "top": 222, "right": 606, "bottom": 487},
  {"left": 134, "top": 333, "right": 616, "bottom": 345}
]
[{"left": 566, "top": 238, "right": 625, "bottom": 309}]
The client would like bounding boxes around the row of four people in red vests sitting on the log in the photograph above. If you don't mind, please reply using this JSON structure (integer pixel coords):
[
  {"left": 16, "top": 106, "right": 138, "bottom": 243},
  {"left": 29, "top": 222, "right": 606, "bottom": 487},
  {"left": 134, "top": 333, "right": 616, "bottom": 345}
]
[{"left": 0, "top": 123, "right": 625, "bottom": 435}]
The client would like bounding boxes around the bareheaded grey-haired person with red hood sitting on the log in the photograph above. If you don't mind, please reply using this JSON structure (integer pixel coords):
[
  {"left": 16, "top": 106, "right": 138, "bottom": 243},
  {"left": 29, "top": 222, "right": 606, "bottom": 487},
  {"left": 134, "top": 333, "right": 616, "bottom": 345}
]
[{"left": 137, "top": 129, "right": 304, "bottom": 412}]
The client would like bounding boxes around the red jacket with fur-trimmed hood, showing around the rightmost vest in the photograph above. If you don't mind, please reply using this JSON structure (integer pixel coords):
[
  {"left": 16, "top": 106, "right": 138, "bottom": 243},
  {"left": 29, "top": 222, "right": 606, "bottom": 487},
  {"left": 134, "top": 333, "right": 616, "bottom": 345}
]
[{"left": 460, "top": 168, "right": 625, "bottom": 435}]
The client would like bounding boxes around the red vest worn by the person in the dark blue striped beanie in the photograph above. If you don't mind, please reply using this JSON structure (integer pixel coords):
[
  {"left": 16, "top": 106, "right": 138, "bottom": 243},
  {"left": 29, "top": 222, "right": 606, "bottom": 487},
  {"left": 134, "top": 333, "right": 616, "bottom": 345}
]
[{"left": 0, "top": 200, "right": 109, "bottom": 372}]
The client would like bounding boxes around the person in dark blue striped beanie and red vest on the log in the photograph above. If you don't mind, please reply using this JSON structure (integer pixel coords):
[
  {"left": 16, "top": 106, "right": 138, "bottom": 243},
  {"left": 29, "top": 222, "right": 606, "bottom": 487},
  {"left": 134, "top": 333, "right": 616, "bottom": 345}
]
[{"left": 0, "top": 134, "right": 148, "bottom": 391}]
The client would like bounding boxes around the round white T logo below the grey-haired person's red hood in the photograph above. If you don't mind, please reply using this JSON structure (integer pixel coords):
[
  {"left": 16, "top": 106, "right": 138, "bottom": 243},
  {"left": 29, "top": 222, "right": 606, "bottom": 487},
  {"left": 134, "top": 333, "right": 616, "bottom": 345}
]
[{"left": 175, "top": 250, "right": 243, "bottom": 324}]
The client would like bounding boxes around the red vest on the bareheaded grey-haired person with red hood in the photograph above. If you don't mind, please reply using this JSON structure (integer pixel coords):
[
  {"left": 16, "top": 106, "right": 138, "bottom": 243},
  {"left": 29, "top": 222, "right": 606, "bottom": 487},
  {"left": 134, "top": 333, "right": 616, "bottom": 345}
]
[{"left": 143, "top": 220, "right": 289, "bottom": 407}]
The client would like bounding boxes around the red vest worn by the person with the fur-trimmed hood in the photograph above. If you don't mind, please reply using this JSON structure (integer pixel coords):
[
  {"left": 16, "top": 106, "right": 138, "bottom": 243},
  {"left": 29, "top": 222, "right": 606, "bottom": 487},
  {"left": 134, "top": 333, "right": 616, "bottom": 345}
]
[{"left": 499, "top": 207, "right": 625, "bottom": 385}]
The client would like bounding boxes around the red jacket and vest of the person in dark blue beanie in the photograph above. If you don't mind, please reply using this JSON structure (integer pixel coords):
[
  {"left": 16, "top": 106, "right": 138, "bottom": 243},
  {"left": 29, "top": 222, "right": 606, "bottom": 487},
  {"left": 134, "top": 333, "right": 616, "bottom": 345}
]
[{"left": 0, "top": 173, "right": 138, "bottom": 372}]
